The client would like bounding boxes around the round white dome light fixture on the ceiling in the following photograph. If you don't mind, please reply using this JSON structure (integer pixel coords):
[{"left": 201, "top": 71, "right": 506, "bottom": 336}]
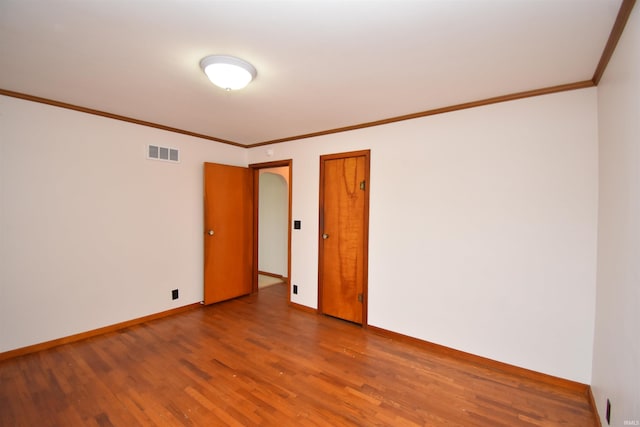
[{"left": 200, "top": 55, "right": 258, "bottom": 90}]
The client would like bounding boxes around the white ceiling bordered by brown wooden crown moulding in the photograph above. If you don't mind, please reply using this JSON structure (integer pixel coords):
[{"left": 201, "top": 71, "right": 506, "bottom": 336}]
[{"left": 0, "top": 0, "right": 621, "bottom": 145}]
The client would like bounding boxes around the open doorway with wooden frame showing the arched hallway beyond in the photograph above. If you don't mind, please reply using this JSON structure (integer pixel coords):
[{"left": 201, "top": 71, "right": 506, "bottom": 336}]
[{"left": 249, "top": 160, "right": 292, "bottom": 301}]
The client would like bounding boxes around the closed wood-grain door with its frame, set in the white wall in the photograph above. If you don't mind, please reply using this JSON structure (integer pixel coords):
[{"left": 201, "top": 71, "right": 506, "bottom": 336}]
[{"left": 318, "top": 150, "right": 369, "bottom": 324}]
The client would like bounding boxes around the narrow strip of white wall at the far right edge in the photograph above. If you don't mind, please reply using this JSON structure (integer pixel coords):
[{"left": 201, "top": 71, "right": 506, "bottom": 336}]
[{"left": 592, "top": 6, "right": 640, "bottom": 426}]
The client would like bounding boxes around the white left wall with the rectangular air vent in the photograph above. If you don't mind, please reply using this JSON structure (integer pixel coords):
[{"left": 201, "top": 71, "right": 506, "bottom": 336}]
[{"left": 0, "top": 97, "right": 246, "bottom": 351}]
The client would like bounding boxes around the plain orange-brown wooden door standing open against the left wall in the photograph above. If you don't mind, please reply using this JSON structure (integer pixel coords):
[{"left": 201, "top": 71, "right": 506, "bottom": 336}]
[{"left": 204, "top": 163, "right": 253, "bottom": 304}]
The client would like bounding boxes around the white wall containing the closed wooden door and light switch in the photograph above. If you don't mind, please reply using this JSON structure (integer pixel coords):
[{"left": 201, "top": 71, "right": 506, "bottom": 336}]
[{"left": 249, "top": 88, "right": 598, "bottom": 383}]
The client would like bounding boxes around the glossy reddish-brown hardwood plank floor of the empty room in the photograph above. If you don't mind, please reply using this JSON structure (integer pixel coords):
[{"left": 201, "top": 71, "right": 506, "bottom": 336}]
[{"left": 0, "top": 285, "right": 596, "bottom": 427}]
